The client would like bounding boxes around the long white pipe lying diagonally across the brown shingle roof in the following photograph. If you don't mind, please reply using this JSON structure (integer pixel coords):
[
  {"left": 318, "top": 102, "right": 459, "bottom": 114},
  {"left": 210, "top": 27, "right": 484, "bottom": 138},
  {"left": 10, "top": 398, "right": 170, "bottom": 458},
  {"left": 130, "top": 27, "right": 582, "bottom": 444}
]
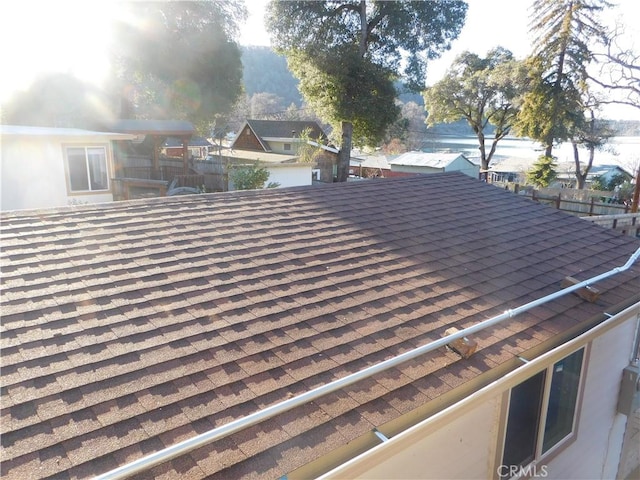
[{"left": 95, "top": 248, "right": 640, "bottom": 480}]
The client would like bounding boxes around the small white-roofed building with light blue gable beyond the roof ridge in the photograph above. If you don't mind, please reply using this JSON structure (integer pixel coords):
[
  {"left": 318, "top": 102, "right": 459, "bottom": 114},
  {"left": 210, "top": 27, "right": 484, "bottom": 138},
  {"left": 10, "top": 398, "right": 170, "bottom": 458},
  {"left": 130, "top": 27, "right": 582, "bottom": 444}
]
[{"left": 389, "top": 151, "right": 480, "bottom": 179}]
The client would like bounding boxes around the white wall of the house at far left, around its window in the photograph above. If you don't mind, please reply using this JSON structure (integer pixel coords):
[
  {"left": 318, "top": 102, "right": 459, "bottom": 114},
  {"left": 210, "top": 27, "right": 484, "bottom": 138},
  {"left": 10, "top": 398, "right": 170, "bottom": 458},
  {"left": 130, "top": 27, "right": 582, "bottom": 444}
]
[{"left": 0, "top": 135, "right": 113, "bottom": 210}]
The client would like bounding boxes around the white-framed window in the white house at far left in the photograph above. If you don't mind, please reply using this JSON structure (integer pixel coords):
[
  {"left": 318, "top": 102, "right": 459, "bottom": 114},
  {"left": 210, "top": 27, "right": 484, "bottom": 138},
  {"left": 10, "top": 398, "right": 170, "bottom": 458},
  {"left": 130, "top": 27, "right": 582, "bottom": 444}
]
[{"left": 65, "top": 146, "right": 109, "bottom": 192}]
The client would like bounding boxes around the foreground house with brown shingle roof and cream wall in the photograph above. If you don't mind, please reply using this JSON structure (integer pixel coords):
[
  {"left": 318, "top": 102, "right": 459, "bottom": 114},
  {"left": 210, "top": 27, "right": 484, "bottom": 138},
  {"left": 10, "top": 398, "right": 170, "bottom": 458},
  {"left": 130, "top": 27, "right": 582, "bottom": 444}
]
[{"left": 0, "top": 173, "right": 640, "bottom": 480}]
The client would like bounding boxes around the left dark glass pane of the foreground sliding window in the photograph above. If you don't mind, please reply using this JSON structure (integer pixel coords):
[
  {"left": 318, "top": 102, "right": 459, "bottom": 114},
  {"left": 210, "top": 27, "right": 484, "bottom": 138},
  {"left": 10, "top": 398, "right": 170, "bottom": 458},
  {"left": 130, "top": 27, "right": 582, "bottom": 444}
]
[{"left": 502, "top": 371, "right": 545, "bottom": 466}]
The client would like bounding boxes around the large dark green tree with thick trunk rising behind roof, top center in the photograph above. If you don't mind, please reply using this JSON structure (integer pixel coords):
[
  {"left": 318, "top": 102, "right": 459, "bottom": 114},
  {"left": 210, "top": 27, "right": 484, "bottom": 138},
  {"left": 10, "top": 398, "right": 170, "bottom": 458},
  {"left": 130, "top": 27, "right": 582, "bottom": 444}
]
[{"left": 266, "top": 0, "right": 467, "bottom": 181}]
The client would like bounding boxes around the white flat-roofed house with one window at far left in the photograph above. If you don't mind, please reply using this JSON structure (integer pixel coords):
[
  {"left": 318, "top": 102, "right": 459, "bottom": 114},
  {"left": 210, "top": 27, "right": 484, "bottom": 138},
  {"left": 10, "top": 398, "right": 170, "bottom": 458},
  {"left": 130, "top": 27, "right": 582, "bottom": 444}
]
[{"left": 0, "top": 125, "right": 135, "bottom": 210}]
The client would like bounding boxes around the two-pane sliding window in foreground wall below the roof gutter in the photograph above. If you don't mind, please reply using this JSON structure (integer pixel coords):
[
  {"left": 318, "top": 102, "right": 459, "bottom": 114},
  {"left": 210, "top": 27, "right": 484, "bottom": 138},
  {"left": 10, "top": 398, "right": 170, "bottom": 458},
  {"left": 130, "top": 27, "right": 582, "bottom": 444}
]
[{"left": 501, "top": 348, "right": 584, "bottom": 477}]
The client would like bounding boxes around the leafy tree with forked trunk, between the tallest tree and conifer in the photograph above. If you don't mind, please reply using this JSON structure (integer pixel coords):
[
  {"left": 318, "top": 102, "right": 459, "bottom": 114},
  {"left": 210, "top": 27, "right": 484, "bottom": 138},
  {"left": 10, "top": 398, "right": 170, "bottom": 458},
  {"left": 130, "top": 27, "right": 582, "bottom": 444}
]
[{"left": 424, "top": 47, "right": 526, "bottom": 176}]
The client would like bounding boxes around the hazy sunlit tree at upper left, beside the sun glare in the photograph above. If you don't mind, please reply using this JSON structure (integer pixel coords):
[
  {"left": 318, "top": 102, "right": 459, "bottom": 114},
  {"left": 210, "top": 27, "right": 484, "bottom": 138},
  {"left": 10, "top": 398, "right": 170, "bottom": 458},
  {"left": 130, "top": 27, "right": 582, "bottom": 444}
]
[{"left": 113, "top": 0, "right": 246, "bottom": 132}]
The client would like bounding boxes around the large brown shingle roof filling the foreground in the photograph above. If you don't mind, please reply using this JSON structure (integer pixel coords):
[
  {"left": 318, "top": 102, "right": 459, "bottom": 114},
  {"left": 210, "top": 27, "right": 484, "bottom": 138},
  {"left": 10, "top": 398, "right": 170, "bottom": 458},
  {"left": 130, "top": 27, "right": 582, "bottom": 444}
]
[{"left": 0, "top": 173, "right": 640, "bottom": 479}]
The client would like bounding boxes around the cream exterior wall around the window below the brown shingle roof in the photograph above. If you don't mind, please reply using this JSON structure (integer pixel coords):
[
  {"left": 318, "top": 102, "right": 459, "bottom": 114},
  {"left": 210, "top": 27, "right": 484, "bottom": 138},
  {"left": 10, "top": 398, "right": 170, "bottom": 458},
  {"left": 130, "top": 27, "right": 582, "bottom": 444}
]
[{"left": 321, "top": 307, "right": 637, "bottom": 480}]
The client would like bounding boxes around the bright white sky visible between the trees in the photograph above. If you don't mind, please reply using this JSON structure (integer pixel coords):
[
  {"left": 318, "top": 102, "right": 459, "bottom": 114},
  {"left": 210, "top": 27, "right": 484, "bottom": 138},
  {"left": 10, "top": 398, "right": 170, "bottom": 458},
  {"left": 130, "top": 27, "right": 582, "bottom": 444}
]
[{"left": 0, "top": 0, "right": 640, "bottom": 120}]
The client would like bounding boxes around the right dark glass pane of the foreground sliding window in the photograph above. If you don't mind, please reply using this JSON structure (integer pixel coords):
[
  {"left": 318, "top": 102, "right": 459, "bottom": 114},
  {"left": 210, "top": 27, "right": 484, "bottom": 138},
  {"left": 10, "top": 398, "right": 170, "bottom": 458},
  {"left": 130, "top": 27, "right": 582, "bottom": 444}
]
[{"left": 542, "top": 349, "right": 584, "bottom": 452}]
